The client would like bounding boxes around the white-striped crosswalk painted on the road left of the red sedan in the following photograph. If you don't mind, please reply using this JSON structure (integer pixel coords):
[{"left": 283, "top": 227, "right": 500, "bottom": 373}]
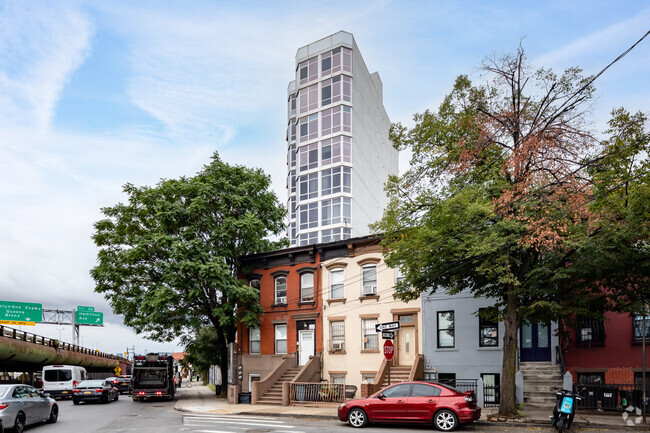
[{"left": 179, "top": 414, "right": 305, "bottom": 433}]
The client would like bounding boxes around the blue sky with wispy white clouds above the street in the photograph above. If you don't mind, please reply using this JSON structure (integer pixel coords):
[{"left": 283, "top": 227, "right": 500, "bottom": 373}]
[{"left": 0, "top": 0, "right": 650, "bottom": 353}]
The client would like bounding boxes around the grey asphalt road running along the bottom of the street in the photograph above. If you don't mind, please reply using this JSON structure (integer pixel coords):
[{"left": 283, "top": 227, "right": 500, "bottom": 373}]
[{"left": 17, "top": 389, "right": 612, "bottom": 433}]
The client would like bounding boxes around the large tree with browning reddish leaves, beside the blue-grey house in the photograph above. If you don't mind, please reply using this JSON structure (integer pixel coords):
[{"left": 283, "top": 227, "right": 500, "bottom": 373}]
[{"left": 374, "top": 48, "right": 599, "bottom": 415}]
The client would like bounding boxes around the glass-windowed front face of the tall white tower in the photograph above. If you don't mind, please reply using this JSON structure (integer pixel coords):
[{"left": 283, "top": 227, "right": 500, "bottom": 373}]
[{"left": 287, "top": 32, "right": 388, "bottom": 246}]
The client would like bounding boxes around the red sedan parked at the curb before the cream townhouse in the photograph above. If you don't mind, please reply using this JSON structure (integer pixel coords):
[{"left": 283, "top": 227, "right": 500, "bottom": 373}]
[{"left": 339, "top": 382, "right": 481, "bottom": 431}]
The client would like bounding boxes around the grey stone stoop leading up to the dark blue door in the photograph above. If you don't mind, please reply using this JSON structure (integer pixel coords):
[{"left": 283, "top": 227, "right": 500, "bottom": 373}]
[{"left": 520, "top": 362, "right": 562, "bottom": 413}]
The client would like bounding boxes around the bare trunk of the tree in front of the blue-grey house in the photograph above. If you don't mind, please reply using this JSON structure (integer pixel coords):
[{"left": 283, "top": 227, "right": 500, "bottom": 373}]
[{"left": 499, "top": 292, "right": 521, "bottom": 416}]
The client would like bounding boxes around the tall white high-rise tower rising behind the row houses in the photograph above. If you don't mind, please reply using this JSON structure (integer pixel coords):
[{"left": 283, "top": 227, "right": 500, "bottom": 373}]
[{"left": 287, "top": 31, "right": 398, "bottom": 245}]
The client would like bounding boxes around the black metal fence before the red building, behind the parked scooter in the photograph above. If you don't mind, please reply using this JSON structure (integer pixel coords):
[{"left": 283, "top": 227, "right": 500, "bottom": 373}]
[{"left": 574, "top": 383, "right": 643, "bottom": 412}]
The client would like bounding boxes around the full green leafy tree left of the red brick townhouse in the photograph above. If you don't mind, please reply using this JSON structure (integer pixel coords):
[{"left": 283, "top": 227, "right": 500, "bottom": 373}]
[{"left": 91, "top": 153, "right": 285, "bottom": 384}]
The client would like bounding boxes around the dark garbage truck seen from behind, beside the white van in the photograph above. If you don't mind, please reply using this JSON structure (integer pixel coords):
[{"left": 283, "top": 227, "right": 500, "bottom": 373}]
[{"left": 131, "top": 353, "right": 175, "bottom": 401}]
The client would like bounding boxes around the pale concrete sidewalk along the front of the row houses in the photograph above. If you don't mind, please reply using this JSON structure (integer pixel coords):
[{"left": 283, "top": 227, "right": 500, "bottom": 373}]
[{"left": 174, "top": 382, "right": 650, "bottom": 431}]
